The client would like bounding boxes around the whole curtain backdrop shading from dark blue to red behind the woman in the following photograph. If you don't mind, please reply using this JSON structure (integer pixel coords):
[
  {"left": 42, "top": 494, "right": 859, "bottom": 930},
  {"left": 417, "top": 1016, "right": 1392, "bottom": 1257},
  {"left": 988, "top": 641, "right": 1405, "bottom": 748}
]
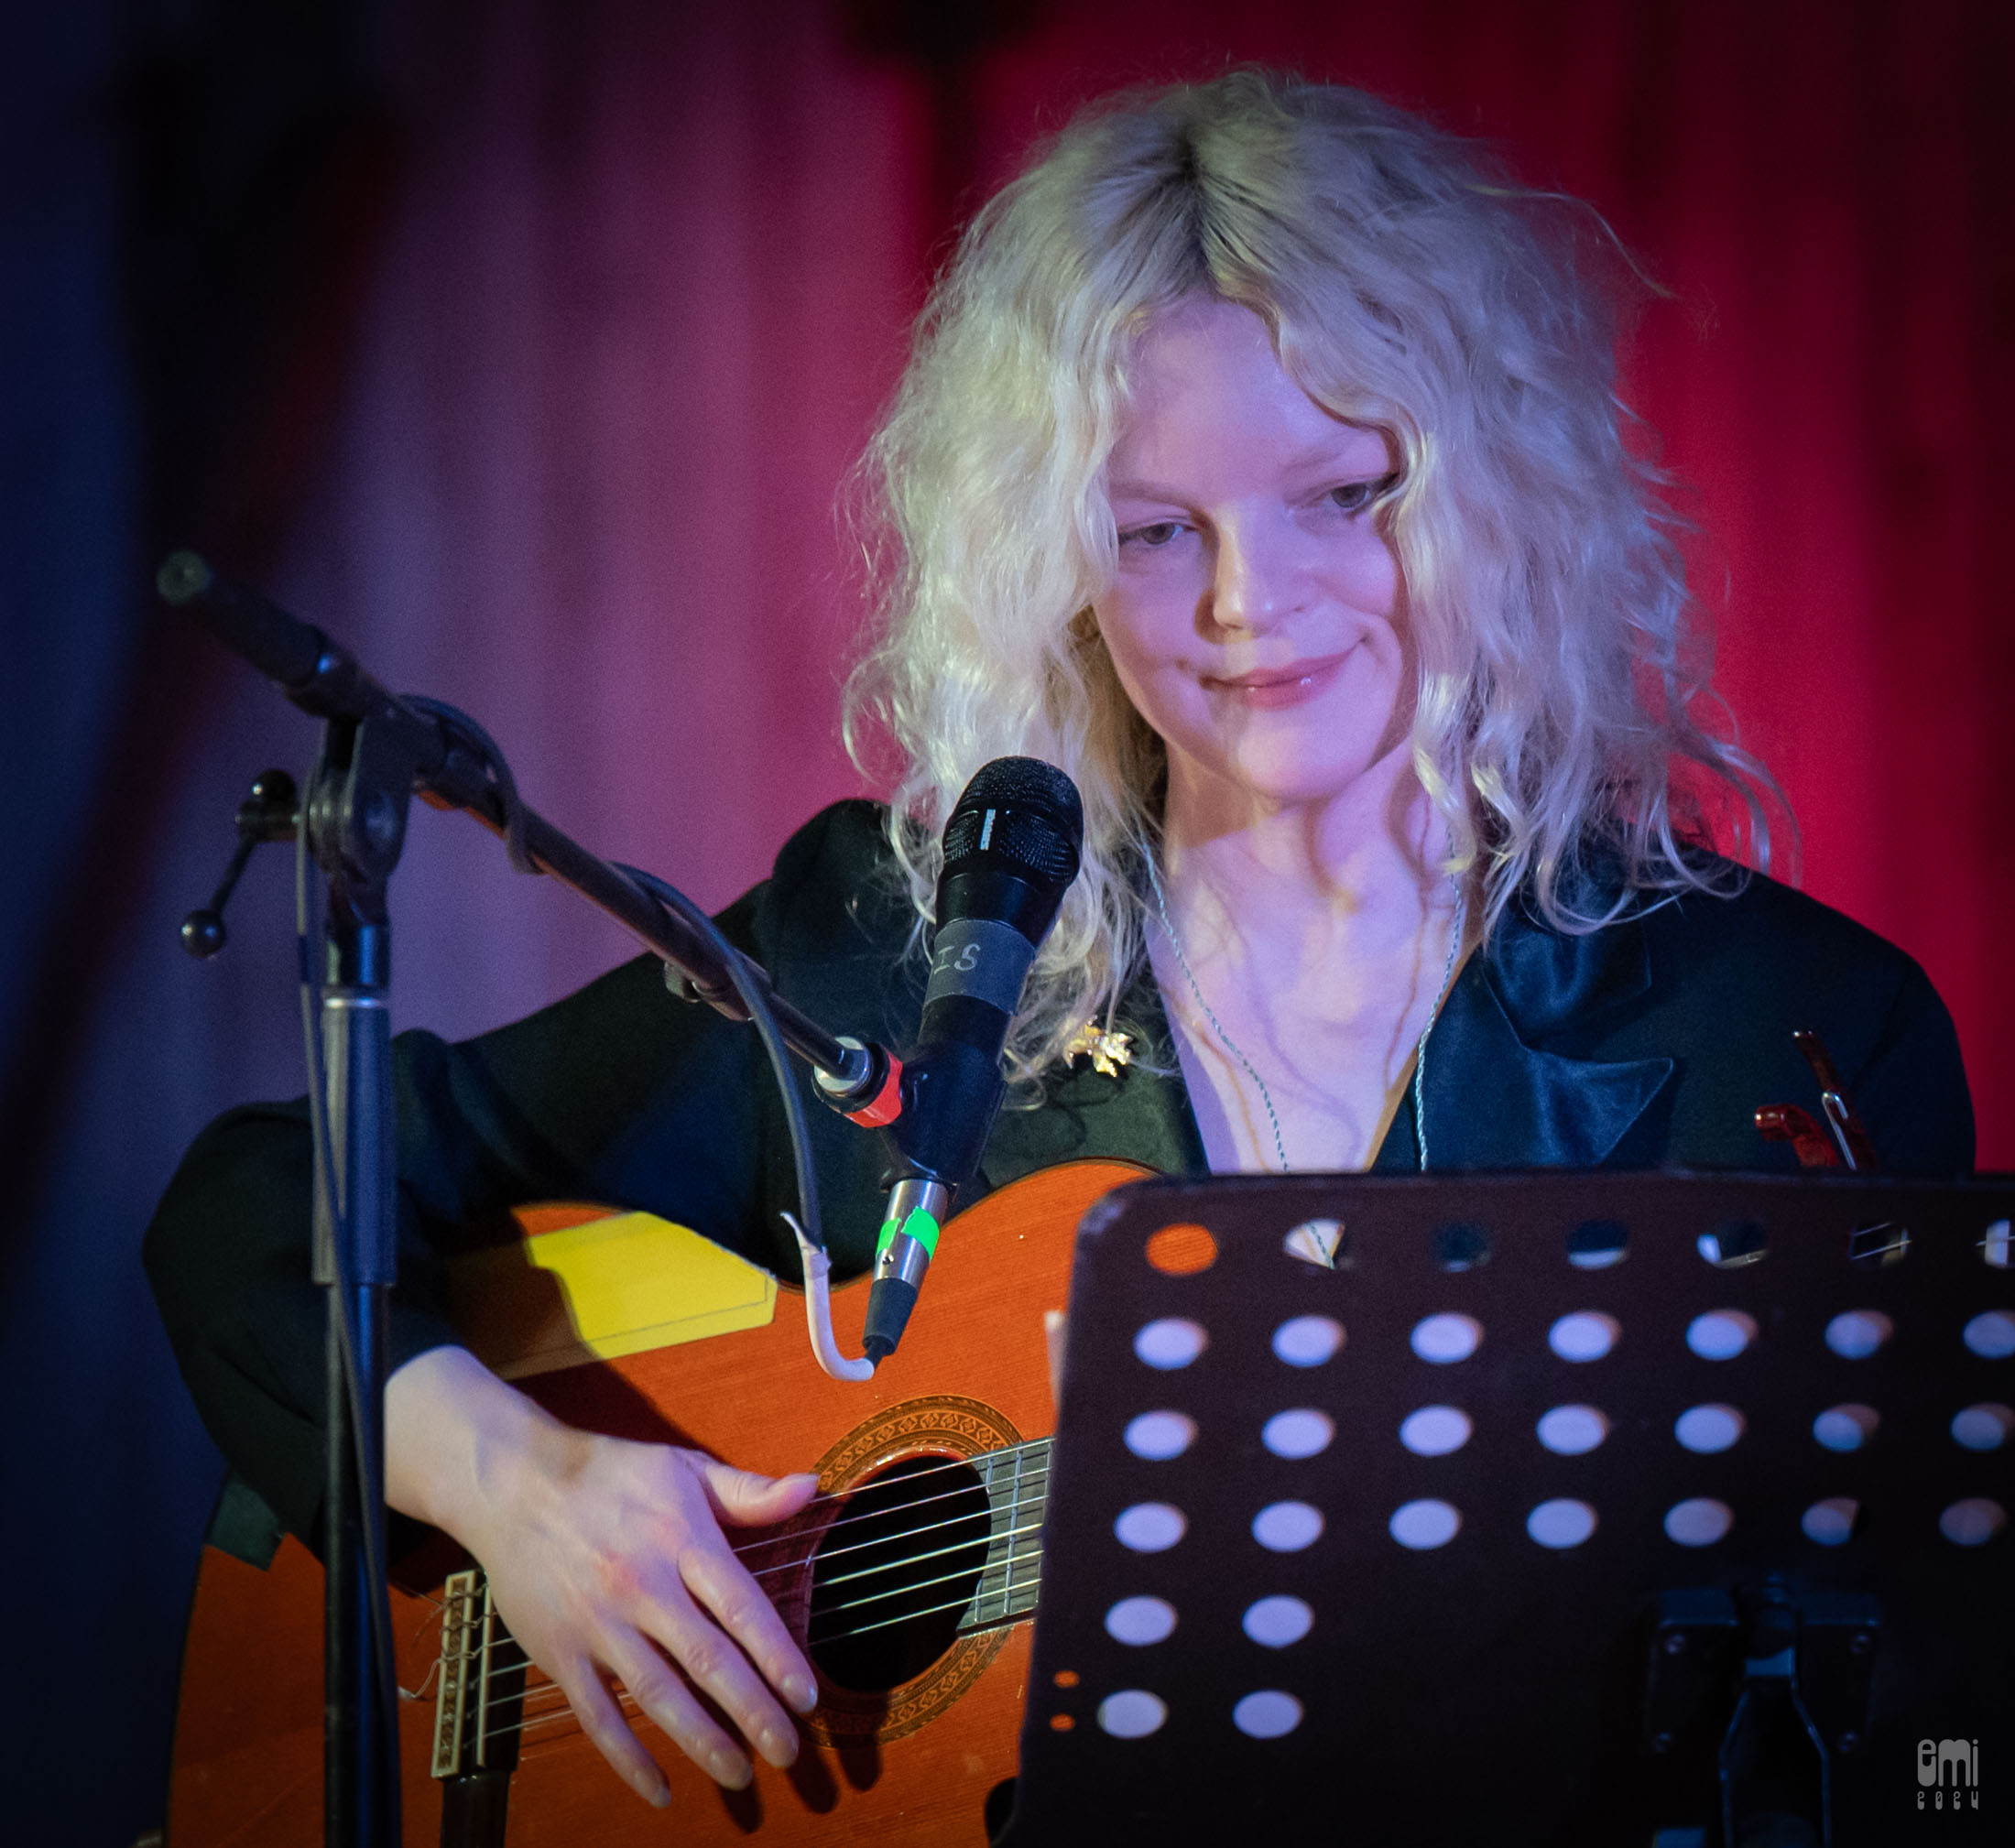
[{"left": 0, "top": 0, "right": 2015, "bottom": 1848}]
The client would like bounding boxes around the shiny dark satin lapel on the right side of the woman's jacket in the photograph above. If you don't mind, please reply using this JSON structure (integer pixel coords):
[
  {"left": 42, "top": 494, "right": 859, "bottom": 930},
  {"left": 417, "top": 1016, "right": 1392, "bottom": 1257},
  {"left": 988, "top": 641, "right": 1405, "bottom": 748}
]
[{"left": 1418, "top": 913, "right": 1672, "bottom": 1169}]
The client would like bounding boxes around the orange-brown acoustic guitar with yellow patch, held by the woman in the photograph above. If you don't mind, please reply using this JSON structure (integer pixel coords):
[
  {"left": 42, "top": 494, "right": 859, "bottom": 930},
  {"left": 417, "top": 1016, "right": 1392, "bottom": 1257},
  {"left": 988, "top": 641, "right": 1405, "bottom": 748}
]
[{"left": 168, "top": 1161, "right": 1147, "bottom": 1848}]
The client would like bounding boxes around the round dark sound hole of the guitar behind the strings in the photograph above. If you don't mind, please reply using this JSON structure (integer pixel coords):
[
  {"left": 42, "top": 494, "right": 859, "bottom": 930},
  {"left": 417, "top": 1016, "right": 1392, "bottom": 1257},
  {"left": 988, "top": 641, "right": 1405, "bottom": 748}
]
[{"left": 808, "top": 1457, "right": 989, "bottom": 1693}]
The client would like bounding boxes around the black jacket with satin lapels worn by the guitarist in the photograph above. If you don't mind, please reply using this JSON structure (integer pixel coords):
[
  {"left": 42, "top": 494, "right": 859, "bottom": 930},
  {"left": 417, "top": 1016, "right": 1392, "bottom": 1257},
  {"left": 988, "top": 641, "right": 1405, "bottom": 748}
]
[{"left": 147, "top": 802, "right": 1973, "bottom": 1536}]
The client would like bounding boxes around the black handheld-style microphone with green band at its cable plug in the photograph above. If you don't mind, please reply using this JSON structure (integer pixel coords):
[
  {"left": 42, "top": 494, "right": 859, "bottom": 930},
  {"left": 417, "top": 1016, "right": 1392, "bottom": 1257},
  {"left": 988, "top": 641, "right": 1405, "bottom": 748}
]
[{"left": 863, "top": 757, "right": 1084, "bottom": 1364}]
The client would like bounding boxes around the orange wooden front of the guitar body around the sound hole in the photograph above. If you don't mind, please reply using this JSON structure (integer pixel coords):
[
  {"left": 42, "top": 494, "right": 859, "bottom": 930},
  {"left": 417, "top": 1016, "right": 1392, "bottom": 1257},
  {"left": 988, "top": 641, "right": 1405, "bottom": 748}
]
[{"left": 168, "top": 1161, "right": 1147, "bottom": 1848}]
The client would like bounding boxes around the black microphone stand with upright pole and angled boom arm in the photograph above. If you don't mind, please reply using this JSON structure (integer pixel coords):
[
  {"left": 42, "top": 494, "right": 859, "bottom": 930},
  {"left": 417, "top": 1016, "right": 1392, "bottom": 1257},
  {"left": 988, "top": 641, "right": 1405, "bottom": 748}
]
[{"left": 155, "top": 552, "right": 900, "bottom": 1848}]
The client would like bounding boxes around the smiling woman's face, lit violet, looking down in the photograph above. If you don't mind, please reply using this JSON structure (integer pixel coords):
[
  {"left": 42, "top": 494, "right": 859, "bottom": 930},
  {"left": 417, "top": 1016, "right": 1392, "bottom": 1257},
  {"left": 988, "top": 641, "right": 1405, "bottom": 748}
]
[{"left": 1095, "top": 300, "right": 1414, "bottom": 810}]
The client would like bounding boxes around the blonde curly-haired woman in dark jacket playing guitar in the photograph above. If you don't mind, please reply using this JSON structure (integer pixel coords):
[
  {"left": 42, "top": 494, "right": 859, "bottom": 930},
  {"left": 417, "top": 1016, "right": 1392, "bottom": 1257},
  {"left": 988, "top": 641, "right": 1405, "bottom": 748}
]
[{"left": 149, "top": 72, "right": 1973, "bottom": 1799}]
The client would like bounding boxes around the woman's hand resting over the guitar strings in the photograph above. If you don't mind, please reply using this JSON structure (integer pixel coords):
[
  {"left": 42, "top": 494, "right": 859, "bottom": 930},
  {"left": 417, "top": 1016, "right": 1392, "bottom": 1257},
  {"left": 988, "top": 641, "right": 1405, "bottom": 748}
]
[{"left": 385, "top": 1348, "right": 818, "bottom": 1804}]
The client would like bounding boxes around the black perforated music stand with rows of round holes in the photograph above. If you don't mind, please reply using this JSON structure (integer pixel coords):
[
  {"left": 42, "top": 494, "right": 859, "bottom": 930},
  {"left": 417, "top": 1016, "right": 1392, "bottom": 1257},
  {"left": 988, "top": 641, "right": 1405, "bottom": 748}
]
[{"left": 1004, "top": 1175, "right": 2015, "bottom": 1848}]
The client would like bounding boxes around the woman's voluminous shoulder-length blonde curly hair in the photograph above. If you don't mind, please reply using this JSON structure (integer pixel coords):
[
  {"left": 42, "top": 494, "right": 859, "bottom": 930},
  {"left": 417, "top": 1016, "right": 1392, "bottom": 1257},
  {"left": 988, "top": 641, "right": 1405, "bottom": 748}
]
[{"left": 846, "top": 71, "right": 1780, "bottom": 1091}]
